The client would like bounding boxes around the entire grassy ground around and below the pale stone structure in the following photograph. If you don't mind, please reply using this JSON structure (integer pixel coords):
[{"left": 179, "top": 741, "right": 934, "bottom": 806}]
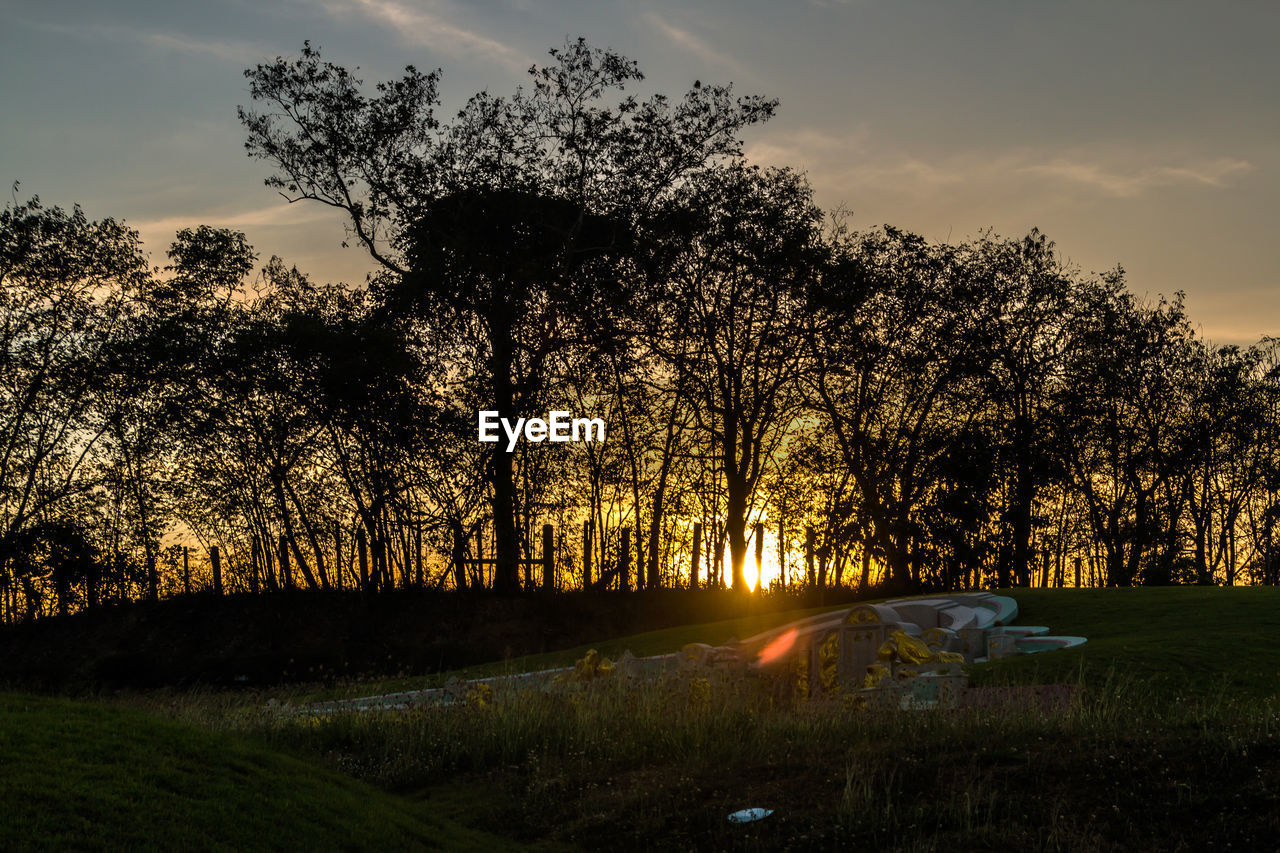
[{"left": 0, "top": 588, "right": 1280, "bottom": 850}]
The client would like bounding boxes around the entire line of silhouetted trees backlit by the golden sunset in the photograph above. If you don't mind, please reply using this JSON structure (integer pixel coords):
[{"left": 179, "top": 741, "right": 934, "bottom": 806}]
[{"left": 0, "top": 40, "right": 1280, "bottom": 621}]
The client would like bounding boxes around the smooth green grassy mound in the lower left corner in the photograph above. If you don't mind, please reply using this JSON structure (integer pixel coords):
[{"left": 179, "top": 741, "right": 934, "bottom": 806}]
[{"left": 0, "top": 694, "right": 524, "bottom": 850}]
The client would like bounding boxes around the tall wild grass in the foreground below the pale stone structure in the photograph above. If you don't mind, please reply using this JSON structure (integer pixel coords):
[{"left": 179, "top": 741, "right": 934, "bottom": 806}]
[{"left": 160, "top": 670, "right": 1280, "bottom": 850}]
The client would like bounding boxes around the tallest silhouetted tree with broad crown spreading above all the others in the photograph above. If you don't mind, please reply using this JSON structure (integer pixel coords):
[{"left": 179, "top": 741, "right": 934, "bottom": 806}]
[{"left": 241, "top": 40, "right": 776, "bottom": 590}]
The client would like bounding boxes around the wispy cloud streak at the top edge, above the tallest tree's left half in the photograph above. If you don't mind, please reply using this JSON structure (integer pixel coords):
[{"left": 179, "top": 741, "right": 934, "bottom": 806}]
[{"left": 312, "top": 0, "right": 527, "bottom": 69}]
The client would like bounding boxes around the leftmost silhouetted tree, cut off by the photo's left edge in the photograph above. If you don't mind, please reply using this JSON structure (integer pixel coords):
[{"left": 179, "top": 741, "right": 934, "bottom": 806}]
[{"left": 0, "top": 199, "right": 148, "bottom": 614}]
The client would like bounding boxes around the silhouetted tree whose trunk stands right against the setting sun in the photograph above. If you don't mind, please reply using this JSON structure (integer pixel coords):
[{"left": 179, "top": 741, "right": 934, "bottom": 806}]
[{"left": 658, "top": 164, "right": 824, "bottom": 590}]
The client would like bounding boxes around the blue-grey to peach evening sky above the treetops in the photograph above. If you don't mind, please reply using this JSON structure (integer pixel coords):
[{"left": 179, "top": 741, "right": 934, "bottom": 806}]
[{"left": 0, "top": 0, "right": 1280, "bottom": 345}]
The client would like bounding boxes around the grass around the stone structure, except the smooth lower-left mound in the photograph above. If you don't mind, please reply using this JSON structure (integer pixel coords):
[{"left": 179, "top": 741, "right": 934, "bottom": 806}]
[{"left": 237, "top": 589, "right": 1280, "bottom": 850}]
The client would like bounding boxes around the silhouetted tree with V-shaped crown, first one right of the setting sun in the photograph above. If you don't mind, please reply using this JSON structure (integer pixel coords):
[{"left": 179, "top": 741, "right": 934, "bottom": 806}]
[{"left": 808, "top": 228, "right": 991, "bottom": 585}]
